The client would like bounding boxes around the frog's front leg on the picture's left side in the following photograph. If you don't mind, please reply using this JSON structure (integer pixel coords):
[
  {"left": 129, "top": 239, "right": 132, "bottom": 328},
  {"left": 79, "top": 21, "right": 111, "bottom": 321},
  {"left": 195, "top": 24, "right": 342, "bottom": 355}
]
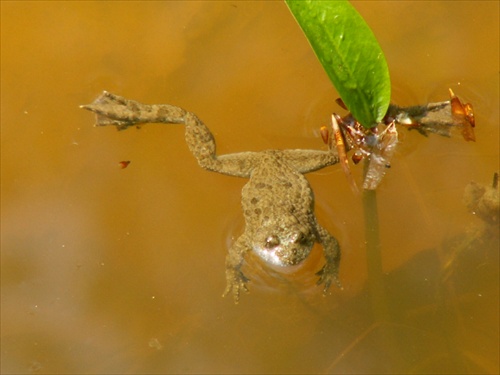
[{"left": 222, "top": 233, "right": 250, "bottom": 303}]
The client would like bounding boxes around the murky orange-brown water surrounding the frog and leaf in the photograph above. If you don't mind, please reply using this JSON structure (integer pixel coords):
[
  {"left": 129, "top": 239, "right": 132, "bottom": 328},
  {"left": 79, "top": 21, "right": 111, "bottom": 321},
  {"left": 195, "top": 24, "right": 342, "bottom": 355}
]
[{"left": 1, "top": 1, "right": 499, "bottom": 374}]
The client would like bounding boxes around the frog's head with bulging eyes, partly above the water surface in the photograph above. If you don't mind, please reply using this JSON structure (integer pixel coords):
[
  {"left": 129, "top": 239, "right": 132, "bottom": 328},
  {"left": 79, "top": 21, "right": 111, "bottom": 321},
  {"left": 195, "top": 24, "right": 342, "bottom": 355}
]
[{"left": 252, "top": 225, "right": 315, "bottom": 267}]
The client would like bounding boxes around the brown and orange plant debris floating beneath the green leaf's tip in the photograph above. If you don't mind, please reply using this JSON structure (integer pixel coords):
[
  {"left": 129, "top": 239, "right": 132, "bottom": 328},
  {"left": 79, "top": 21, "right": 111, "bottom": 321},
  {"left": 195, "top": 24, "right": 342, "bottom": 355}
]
[{"left": 328, "top": 89, "right": 476, "bottom": 192}]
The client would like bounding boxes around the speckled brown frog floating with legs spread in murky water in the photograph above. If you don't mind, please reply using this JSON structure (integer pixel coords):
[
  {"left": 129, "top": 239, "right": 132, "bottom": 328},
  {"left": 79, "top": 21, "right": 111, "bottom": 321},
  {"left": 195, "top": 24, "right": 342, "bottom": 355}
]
[{"left": 80, "top": 91, "right": 342, "bottom": 303}]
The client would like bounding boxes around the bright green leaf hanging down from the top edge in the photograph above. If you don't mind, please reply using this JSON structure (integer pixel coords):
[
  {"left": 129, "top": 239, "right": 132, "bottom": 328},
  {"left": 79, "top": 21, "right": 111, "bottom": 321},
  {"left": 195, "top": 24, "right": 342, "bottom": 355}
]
[{"left": 285, "top": 0, "right": 391, "bottom": 128}]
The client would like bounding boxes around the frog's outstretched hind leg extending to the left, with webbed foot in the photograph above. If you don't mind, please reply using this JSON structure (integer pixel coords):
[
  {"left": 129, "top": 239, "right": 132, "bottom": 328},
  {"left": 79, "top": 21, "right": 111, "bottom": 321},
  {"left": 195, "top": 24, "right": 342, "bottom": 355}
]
[{"left": 81, "top": 91, "right": 259, "bottom": 177}]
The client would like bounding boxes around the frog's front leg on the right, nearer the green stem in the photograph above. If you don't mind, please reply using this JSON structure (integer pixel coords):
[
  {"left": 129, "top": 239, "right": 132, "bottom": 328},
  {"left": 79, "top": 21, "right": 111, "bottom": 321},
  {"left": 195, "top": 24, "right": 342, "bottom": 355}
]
[{"left": 316, "top": 224, "right": 342, "bottom": 294}]
